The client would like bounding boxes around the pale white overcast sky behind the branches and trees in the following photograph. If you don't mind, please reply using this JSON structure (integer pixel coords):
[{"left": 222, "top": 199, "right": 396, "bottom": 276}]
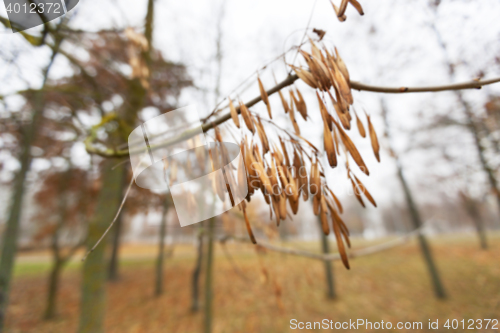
[{"left": 0, "top": 0, "right": 500, "bottom": 228}]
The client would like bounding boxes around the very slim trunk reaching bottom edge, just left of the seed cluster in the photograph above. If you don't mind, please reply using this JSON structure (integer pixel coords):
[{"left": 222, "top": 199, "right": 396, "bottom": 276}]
[{"left": 203, "top": 217, "right": 215, "bottom": 333}]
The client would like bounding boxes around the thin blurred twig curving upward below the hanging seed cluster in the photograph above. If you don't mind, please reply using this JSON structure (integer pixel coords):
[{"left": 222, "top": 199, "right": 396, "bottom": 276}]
[{"left": 220, "top": 228, "right": 422, "bottom": 261}]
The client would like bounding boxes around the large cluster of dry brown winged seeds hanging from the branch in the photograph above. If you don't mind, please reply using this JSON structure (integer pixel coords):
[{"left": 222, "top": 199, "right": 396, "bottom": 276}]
[{"left": 216, "top": 40, "right": 380, "bottom": 267}]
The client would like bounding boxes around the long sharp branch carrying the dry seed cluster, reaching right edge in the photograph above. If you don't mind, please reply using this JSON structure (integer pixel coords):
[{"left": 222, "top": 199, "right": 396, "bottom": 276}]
[{"left": 85, "top": 74, "right": 500, "bottom": 157}]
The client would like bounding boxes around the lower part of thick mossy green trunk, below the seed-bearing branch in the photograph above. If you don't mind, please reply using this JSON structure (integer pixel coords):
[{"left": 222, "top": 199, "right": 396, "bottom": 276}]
[{"left": 78, "top": 159, "right": 124, "bottom": 333}]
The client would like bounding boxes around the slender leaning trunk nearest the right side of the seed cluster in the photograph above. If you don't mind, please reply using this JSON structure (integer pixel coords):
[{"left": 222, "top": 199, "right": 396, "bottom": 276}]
[{"left": 382, "top": 101, "right": 446, "bottom": 298}]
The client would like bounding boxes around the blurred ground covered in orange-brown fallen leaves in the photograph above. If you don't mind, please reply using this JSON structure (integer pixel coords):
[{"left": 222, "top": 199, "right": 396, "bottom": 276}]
[{"left": 7, "top": 233, "right": 500, "bottom": 333}]
